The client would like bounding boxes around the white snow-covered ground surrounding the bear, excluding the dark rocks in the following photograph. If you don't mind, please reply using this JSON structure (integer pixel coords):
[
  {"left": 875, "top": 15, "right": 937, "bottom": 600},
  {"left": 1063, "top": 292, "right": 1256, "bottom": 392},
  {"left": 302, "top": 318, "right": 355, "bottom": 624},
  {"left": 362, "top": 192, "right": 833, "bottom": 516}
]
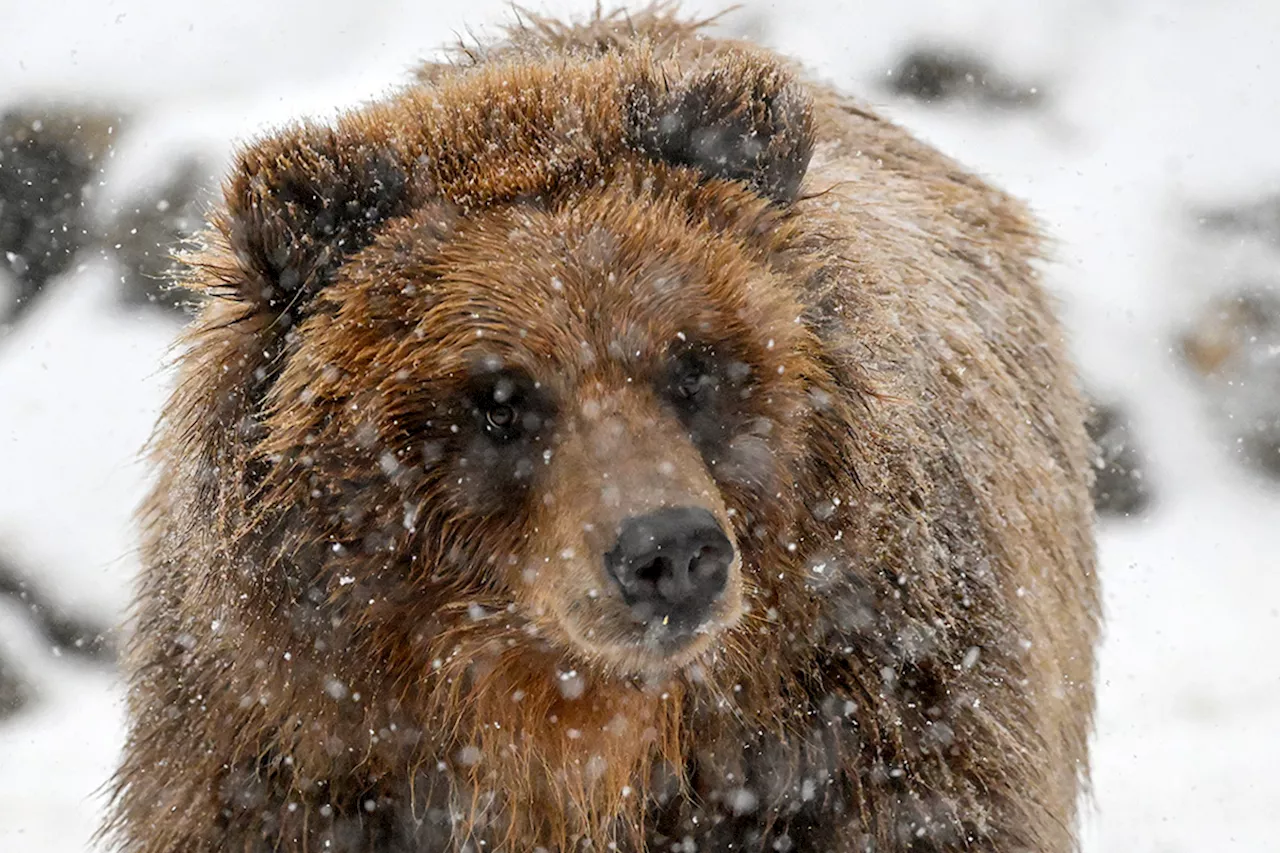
[{"left": 0, "top": 0, "right": 1280, "bottom": 853}]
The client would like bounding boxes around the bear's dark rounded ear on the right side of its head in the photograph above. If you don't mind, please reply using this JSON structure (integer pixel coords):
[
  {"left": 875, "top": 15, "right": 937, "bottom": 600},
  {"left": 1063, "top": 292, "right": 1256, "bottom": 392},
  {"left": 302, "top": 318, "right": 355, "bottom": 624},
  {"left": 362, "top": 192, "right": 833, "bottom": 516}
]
[{"left": 628, "top": 53, "right": 814, "bottom": 204}]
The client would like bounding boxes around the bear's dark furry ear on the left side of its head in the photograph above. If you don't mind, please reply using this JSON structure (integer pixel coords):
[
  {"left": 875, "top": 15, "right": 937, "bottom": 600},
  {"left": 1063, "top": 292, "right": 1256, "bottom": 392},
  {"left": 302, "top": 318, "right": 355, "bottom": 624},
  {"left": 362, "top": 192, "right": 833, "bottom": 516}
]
[{"left": 216, "top": 118, "right": 412, "bottom": 315}]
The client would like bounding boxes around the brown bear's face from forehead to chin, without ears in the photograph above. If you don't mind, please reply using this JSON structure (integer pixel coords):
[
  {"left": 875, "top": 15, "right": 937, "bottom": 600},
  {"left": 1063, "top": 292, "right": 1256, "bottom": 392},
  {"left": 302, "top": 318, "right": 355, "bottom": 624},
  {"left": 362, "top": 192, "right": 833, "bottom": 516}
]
[{"left": 264, "top": 175, "right": 815, "bottom": 675}]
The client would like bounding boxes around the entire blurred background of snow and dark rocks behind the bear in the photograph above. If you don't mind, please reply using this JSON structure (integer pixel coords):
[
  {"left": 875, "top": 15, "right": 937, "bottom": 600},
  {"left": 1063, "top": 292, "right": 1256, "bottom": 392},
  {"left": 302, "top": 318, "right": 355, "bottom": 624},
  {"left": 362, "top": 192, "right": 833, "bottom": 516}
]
[{"left": 0, "top": 0, "right": 1280, "bottom": 853}]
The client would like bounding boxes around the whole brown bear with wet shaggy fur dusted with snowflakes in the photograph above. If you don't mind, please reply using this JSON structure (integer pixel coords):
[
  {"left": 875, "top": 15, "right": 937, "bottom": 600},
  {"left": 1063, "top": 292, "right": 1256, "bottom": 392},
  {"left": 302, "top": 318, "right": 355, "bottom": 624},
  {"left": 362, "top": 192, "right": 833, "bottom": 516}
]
[{"left": 110, "top": 6, "right": 1098, "bottom": 853}]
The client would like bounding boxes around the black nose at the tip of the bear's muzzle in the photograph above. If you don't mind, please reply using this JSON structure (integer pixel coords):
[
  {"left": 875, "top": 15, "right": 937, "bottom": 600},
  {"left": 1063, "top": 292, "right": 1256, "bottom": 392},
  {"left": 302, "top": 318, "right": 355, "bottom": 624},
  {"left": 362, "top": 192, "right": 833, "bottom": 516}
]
[{"left": 604, "top": 506, "right": 733, "bottom": 630}]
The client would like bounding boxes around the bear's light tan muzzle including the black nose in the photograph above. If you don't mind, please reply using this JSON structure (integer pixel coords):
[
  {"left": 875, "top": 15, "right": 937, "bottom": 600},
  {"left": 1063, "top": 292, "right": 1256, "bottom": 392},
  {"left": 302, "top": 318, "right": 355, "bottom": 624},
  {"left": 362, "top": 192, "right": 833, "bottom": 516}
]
[{"left": 521, "top": 386, "right": 744, "bottom": 675}]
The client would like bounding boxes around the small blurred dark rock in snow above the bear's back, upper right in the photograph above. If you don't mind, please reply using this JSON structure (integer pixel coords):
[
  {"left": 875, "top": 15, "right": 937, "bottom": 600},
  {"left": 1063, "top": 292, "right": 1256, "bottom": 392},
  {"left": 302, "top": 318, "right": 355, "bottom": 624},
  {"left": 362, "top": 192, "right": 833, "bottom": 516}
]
[{"left": 888, "top": 47, "right": 1042, "bottom": 108}]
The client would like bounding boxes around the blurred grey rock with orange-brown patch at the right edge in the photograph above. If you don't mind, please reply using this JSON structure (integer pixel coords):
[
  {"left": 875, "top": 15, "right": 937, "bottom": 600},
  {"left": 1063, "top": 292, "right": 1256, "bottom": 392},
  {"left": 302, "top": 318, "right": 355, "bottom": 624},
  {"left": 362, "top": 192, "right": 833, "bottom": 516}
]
[{"left": 1181, "top": 285, "right": 1280, "bottom": 479}]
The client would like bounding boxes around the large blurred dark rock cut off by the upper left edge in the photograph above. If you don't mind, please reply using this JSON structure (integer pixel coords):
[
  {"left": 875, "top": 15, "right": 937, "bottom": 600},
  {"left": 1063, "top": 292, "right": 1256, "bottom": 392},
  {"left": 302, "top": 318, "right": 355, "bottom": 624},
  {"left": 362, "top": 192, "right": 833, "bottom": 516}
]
[{"left": 0, "top": 105, "right": 119, "bottom": 321}]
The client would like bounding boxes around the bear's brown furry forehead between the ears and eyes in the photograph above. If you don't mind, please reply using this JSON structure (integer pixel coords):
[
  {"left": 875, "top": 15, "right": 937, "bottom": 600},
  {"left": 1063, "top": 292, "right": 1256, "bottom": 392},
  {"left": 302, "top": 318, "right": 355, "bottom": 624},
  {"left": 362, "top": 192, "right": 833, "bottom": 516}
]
[{"left": 339, "top": 192, "right": 800, "bottom": 375}]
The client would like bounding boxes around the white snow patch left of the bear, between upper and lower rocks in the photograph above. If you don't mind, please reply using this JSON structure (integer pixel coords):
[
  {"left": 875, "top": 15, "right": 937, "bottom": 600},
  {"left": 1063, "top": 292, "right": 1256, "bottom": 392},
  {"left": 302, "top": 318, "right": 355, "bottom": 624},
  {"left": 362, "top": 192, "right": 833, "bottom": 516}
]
[{"left": 0, "top": 261, "right": 173, "bottom": 622}]
